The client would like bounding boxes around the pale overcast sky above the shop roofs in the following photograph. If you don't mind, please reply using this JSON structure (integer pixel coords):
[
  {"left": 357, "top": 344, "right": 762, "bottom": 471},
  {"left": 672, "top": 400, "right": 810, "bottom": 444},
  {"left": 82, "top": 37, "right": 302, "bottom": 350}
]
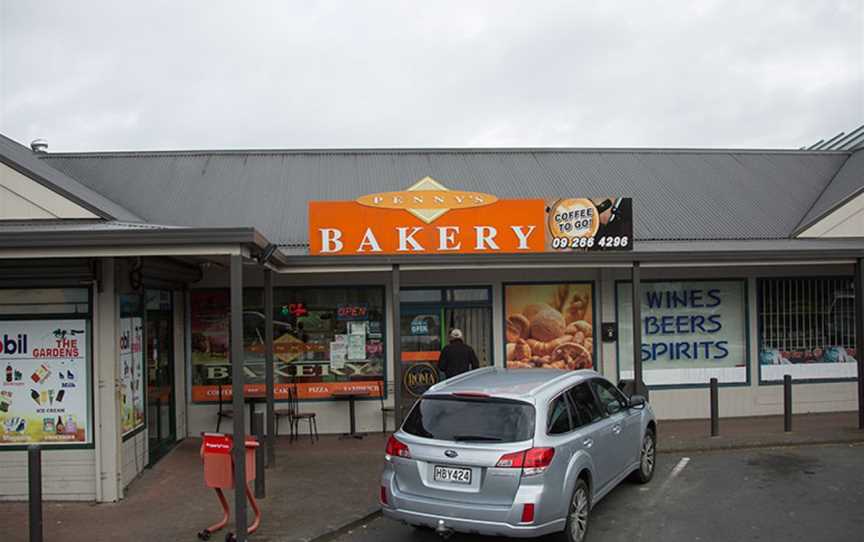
[{"left": 0, "top": 0, "right": 864, "bottom": 151}]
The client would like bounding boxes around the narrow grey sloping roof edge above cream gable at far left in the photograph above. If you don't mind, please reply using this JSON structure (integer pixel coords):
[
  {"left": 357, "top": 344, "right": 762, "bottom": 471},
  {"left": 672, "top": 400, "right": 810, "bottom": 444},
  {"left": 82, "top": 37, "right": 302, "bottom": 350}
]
[{"left": 0, "top": 134, "right": 142, "bottom": 222}]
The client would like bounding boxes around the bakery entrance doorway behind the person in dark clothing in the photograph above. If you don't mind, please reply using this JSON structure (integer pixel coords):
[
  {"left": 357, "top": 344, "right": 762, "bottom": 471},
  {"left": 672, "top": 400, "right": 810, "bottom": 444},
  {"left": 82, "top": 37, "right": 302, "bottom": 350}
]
[{"left": 399, "top": 292, "right": 493, "bottom": 414}]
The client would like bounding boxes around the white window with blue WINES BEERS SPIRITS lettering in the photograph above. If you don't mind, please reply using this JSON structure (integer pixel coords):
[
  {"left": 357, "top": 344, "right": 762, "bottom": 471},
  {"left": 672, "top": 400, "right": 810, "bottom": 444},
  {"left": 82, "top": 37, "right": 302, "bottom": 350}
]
[{"left": 617, "top": 280, "right": 748, "bottom": 386}]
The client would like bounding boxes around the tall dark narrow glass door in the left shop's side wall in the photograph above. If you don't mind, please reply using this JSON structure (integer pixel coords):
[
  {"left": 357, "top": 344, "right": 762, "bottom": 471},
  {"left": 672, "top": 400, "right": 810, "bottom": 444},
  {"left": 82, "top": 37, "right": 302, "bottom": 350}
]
[{"left": 144, "top": 290, "right": 177, "bottom": 465}]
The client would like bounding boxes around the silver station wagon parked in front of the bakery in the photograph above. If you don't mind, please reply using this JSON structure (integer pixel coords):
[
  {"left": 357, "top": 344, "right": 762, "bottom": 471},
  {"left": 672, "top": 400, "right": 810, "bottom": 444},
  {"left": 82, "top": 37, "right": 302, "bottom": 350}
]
[{"left": 380, "top": 368, "right": 657, "bottom": 542}]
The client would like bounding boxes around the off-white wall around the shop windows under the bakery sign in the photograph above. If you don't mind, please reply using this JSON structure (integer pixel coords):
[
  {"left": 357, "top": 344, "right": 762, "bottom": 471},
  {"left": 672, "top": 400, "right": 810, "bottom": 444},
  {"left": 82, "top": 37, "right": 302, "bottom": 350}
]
[{"left": 182, "top": 265, "right": 857, "bottom": 435}]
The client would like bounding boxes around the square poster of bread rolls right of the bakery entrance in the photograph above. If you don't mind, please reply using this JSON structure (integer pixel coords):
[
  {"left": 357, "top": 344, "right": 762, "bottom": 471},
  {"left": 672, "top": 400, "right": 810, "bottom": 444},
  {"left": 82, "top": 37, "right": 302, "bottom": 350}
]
[{"left": 504, "top": 282, "right": 594, "bottom": 370}]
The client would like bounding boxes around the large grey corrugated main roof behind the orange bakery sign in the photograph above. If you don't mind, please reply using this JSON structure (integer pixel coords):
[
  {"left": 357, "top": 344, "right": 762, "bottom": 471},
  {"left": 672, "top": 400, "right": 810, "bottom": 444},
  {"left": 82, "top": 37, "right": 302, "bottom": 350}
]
[{"left": 43, "top": 149, "right": 848, "bottom": 244}]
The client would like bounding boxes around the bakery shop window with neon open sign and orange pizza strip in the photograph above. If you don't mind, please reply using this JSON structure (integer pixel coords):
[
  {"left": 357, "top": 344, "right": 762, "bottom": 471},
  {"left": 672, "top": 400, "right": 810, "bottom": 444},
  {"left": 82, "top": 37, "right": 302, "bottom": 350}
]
[{"left": 191, "top": 287, "right": 385, "bottom": 401}]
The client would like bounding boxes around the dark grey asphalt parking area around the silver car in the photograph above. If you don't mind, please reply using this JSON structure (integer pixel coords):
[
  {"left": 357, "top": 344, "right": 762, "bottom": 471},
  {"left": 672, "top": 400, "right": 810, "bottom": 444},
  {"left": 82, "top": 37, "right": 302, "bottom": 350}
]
[{"left": 338, "top": 444, "right": 864, "bottom": 542}]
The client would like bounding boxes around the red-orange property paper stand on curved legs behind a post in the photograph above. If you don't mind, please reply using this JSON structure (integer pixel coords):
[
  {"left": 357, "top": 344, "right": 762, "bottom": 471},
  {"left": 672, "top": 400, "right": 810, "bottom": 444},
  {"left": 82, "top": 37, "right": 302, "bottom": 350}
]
[{"left": 198, "top": 433, "right": 261, "bottom": 540}]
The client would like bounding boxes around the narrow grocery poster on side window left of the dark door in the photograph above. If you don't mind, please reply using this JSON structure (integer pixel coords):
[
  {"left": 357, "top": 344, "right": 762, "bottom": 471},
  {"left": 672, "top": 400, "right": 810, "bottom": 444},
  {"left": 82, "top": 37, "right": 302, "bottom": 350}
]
[{"left": 120, "top": 317, "right": 144, "bottom": 436}]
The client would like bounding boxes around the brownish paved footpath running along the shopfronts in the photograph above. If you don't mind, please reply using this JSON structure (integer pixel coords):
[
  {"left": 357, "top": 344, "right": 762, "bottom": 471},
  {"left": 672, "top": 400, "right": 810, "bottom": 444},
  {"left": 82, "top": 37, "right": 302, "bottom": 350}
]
[{"left": 6, "top": 412, "right": 864, "bottom": 542}]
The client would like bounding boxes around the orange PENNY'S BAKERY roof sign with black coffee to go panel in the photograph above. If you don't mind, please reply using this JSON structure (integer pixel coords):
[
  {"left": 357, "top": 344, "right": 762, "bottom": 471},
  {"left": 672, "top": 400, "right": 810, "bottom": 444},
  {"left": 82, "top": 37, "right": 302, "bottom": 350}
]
[{"left": 309, "top": 177, "right": 633, "bottom": 256}]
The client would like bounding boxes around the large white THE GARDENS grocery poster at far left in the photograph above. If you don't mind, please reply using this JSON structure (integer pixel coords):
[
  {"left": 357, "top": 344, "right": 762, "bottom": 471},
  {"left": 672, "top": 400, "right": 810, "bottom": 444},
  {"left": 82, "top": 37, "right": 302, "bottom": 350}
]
[{"left": 0, "top": 319, "right": 92, "bottom": 446}]
